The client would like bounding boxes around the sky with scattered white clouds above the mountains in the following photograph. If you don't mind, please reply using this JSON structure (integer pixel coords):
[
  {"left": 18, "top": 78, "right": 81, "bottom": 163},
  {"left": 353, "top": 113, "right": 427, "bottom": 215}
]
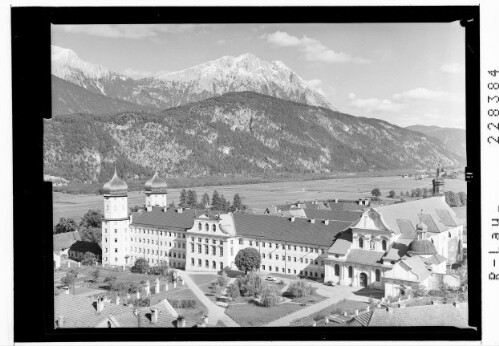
[{"left": 52, "top": 22, "right": 465, "bottom": 129}]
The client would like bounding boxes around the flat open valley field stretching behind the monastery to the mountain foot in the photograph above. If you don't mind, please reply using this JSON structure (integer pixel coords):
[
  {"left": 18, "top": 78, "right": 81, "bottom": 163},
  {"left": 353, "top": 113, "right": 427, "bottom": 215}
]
[{"left": 53, "top": 176, "right": 467, "bottom": 225}]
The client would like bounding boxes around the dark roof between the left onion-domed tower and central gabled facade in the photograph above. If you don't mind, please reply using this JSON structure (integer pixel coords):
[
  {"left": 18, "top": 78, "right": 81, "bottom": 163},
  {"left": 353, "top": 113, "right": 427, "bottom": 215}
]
[{"left": 132, "top": 208, "right": 196, "bottom": 229}]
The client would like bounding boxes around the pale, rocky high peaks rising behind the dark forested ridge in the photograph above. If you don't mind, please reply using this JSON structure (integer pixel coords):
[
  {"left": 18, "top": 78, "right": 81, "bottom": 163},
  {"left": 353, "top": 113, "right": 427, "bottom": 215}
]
[{"left": 52, "top": 46, "right": 332, "bottom": 114}]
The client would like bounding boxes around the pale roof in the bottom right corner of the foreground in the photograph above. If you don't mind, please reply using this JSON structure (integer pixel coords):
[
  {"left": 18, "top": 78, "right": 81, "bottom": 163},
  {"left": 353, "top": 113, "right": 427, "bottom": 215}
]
[{"left": 369, "top": 303, "right": 469, "bottom": 328}]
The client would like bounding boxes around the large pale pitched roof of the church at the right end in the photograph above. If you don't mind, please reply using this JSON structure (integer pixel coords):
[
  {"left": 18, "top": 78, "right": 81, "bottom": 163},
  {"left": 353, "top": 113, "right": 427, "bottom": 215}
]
[{"left": 375, "top": 196, "right": 459, "bottom": 233}]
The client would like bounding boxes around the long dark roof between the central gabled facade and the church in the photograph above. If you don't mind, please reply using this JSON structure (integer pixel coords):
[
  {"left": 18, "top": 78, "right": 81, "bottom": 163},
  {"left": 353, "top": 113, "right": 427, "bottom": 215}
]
[{"left": 234, "top": 213, "right": 350, "bottom": 246}]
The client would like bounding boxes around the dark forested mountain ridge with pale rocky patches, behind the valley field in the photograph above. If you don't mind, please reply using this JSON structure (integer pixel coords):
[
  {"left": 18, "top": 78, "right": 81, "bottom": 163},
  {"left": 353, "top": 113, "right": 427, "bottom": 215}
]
[{"left": 44, "top": 92, "right": 463, "bottom": 182}]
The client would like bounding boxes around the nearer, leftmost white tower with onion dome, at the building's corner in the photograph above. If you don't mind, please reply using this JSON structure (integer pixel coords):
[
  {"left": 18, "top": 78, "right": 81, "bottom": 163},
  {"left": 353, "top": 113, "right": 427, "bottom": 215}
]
[{"left": 102, "top": 168, "right": 130, "bottom": 266}]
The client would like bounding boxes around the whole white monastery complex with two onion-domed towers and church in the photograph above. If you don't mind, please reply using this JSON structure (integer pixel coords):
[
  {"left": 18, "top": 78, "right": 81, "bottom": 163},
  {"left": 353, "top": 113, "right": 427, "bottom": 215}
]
[{"left": 102, "top": 171, "right": 463, "bottom": 296}]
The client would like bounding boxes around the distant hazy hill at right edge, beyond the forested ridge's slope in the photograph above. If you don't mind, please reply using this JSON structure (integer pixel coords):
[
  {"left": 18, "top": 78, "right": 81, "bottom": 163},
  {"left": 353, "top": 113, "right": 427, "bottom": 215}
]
[{"left": 406, "top": 125, "right": 466, "bottom": 157}]
